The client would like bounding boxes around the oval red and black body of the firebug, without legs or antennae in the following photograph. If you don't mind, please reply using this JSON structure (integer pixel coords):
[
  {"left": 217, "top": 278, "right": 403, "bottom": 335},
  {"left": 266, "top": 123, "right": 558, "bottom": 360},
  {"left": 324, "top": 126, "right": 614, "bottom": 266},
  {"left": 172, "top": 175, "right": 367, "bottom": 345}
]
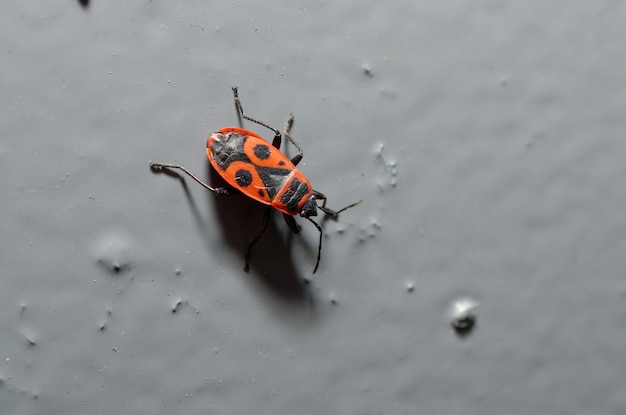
[{"left": 206, "top": 127, "right": 317, "bottom": 216}]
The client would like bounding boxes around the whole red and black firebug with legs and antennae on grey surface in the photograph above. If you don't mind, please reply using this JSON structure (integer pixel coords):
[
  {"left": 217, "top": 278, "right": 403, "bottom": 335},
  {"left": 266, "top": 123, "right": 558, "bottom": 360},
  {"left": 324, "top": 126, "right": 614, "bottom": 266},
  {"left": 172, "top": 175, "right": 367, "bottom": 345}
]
[{"left": 150, "top": 87, "right": 361, "bottom": 273}]
